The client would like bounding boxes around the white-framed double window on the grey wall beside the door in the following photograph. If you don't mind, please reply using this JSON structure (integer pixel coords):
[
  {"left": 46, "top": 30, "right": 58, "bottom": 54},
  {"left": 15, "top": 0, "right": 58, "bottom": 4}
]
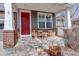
[{"left": 38, "top": 13, "right": 53, "bottom": 28}]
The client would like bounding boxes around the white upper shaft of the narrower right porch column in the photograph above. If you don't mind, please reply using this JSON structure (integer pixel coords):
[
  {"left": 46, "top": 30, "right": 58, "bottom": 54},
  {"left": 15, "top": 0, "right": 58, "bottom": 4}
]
[{"left": 64, "top": 8, "right": 72, "bottom": 29}]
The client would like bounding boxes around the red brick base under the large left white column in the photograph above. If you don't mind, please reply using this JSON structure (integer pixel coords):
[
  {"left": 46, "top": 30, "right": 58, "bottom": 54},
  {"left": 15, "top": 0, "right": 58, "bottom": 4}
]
[{"left": 3, "top": 30, "right": 17, "bottom": 48}]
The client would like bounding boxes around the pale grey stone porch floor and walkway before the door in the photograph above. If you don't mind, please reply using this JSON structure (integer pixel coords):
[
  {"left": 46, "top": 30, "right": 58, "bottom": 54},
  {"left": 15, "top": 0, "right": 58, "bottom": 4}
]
[{"left": 0, "top": 36, "right": 79, "bottom": 56}]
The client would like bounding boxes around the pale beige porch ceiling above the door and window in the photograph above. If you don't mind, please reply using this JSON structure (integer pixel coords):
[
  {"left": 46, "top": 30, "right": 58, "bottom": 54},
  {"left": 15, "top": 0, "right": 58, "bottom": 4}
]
[{"left": 15, "top": 3, "right": 71, "bottom": 13}]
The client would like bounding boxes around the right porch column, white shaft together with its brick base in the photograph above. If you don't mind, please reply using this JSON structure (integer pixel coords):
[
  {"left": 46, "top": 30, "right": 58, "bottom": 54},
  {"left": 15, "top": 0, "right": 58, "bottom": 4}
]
[{"left": 64, "top": 8, "right": 72, "bottom": 39}]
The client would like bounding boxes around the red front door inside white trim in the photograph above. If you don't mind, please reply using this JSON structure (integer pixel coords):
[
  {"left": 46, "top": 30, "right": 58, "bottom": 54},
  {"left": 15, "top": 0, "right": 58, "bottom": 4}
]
[{"left": 21, "top": 12, "right": 30, "bottom": 35}]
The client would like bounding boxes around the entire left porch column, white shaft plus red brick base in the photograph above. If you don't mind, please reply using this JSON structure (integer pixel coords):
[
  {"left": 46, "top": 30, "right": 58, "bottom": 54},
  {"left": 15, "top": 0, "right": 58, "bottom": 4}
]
[{"left": 3, "top": 3, "right": 17, "bottom": 48}]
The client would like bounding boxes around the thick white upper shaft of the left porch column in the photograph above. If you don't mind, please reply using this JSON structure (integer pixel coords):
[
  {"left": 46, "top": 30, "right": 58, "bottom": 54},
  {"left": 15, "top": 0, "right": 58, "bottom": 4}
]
[{"left": 4, "top": 3, "right": 14, "bottom": 30}]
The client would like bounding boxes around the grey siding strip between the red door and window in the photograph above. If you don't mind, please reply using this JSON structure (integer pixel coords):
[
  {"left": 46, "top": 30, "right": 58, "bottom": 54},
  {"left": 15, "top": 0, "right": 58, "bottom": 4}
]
[{"left": 31, "top": 11, "right": 37, "bottom": 29}]
